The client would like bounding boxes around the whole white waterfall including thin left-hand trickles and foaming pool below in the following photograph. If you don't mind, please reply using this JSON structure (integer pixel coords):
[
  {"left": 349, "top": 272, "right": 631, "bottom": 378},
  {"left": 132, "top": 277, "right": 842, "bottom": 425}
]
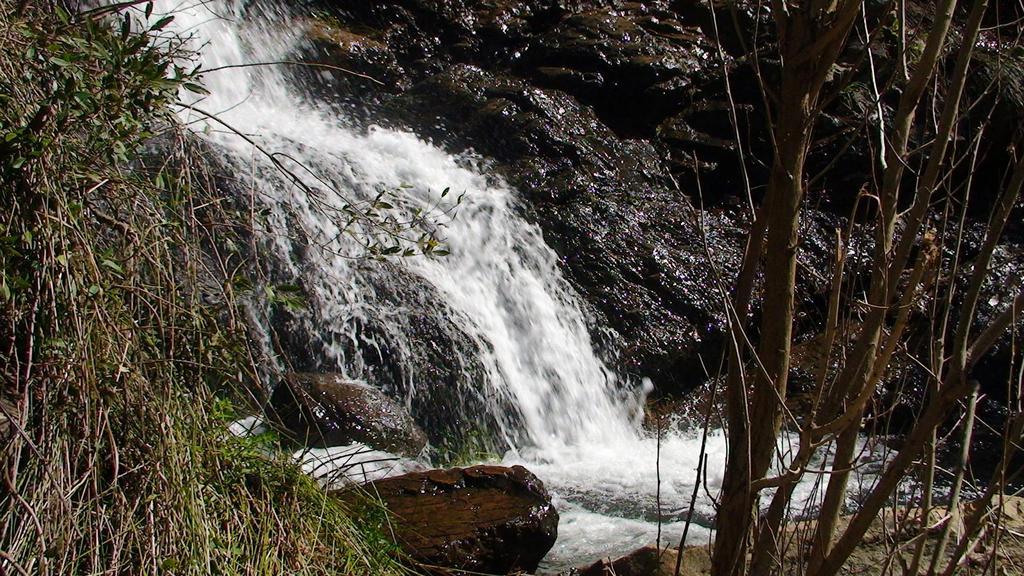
[{"left": 146, "top": 0, "right": 888, "bottom": 566}]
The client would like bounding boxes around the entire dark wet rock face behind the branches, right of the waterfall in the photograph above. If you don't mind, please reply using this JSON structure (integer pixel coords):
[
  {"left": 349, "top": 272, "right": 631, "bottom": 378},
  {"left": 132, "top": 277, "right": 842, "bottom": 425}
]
[{"left": 292, "top": 0, "right": 1024, "bottom": 401}]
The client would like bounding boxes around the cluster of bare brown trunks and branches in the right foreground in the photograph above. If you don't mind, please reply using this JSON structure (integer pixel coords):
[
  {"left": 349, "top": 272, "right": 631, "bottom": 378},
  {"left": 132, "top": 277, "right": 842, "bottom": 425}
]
[{"left": 713, "top": 0, "right": 1024, "bottom": 576}]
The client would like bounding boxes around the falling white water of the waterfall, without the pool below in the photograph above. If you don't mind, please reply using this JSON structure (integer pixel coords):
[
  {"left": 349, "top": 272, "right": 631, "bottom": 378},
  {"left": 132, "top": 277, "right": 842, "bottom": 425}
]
[{"left": 162, "top": 2, "right": 640, "bottom": 448}]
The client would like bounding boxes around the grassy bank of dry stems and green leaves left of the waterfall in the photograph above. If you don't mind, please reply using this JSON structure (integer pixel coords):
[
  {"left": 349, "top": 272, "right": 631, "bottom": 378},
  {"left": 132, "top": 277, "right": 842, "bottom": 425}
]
[{"left": 0, "top": 0, "right": 400, "bottom": 574}]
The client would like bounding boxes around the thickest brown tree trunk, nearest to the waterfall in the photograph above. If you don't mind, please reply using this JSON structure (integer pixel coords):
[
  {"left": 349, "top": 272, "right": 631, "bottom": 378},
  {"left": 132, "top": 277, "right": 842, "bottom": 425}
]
[{"left": 712, "top": 0, "right": 860, "bottom": 576}]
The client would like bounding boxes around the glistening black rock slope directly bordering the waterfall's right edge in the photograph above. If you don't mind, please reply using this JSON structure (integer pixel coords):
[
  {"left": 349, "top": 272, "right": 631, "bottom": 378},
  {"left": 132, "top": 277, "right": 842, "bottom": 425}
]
[{"left": 389, "top": 66, "right": 843, "bottom": 392}]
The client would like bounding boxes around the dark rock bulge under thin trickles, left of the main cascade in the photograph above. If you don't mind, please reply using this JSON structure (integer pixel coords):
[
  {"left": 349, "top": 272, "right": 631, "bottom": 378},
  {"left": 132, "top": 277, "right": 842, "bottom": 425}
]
[{"left": 264, "top": 258, "right": 509, "bottom": 452}]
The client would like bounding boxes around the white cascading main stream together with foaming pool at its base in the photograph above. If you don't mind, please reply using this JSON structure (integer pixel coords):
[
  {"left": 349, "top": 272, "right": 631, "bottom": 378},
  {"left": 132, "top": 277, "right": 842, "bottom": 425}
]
[{"left": 154, "top": 0, "right": 888, "bottom": 567}]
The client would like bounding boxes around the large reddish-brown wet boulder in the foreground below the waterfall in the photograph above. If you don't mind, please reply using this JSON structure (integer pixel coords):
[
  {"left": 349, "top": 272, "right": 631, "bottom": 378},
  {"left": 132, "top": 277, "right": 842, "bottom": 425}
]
[{"left": 336, "top": 466, "right": 558, "bottom": 574}]
